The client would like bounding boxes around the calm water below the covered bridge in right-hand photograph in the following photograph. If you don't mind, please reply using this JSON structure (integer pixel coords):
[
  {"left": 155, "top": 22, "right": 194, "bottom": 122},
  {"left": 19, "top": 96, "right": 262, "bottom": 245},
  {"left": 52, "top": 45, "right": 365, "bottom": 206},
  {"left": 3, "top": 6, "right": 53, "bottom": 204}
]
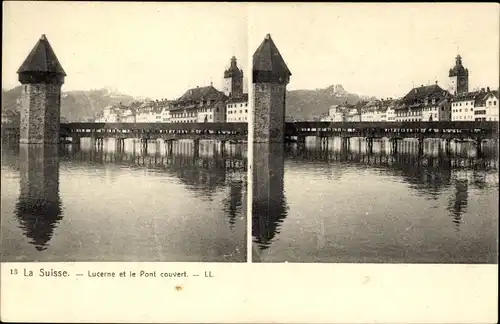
[{"left": 252, "top": 138, "right": 498, "bottom": 263}]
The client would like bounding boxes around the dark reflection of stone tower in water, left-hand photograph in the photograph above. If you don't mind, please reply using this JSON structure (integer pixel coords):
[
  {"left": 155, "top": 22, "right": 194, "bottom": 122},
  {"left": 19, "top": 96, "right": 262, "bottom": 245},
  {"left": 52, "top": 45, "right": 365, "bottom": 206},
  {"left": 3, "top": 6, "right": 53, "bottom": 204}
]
[{"left": 15, "top": 145, "right": 62, "bottom": 251}]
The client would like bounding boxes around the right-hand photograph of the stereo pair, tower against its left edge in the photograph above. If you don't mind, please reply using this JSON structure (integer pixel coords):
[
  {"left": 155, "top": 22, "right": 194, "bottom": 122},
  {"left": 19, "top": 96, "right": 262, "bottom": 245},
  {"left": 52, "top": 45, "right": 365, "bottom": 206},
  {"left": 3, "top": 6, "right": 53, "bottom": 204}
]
[{"left": 249, "top": 3, "right": 500, "bottom": 264}]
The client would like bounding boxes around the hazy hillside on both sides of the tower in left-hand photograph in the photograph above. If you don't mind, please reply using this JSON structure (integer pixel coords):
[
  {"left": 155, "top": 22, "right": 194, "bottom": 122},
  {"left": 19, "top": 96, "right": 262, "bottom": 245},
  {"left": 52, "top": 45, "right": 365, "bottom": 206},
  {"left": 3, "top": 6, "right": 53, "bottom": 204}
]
[{"left": 2, "top": 86, "right": 133, "bottom": 122}]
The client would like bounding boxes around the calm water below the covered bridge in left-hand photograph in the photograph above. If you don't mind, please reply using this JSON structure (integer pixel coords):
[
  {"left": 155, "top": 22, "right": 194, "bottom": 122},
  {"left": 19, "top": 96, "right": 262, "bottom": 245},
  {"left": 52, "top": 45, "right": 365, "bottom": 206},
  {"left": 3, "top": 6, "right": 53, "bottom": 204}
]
[{"left": 1, "top": 139, "right": 247, "bottom": 262}]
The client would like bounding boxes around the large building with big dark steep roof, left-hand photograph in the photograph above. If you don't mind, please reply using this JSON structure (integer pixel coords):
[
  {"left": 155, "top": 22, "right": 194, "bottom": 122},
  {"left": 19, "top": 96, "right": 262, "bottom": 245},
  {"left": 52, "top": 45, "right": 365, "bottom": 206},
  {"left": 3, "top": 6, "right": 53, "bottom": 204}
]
[{"left": 170, "top": 85, "right": 227, "bottom": 123}]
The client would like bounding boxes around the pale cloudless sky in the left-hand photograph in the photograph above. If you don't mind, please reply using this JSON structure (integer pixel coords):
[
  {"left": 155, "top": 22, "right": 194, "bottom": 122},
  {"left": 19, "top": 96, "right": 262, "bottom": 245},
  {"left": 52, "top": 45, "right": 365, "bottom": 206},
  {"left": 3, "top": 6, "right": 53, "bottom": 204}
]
[{"left": 2, "top": 1, "right": 248, "bottom": 99}]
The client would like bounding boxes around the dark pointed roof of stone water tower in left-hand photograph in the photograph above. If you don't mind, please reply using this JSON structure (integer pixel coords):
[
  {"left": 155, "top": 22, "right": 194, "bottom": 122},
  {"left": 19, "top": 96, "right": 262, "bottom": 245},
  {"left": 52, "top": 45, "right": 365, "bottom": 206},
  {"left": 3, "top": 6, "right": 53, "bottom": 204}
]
[{"left": 17, "top": 34, "right": 66, "bottom": 76}]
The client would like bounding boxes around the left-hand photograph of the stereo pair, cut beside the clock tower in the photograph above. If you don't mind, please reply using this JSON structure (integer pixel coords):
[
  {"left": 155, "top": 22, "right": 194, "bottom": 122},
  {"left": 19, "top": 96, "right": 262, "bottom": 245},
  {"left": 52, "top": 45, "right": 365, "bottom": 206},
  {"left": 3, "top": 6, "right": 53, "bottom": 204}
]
[{"left": 1, "top": 2, "right": 248, "bottom": 262}]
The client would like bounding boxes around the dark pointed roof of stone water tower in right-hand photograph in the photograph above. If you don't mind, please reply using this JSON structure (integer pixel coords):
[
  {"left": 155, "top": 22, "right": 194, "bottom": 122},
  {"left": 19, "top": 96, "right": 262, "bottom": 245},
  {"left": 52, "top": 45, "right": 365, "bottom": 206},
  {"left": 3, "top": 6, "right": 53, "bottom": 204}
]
[{"left": 253, "top": 34, "right": 292, "bottom": 77}]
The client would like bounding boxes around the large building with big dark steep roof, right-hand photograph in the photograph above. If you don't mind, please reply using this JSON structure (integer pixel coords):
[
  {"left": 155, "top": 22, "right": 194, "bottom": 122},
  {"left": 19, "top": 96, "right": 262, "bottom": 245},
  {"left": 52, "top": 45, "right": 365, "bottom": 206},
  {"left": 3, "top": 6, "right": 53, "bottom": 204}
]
[{"left": 395, "top": 82, "right": 451, "bottom": 122}]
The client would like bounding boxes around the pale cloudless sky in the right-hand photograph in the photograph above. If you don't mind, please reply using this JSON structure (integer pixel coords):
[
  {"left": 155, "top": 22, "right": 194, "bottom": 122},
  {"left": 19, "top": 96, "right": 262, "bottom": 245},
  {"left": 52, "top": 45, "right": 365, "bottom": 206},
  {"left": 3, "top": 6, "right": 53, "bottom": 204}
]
[{"left": 249, "top": 3, "right": 500, "bottom": 98}]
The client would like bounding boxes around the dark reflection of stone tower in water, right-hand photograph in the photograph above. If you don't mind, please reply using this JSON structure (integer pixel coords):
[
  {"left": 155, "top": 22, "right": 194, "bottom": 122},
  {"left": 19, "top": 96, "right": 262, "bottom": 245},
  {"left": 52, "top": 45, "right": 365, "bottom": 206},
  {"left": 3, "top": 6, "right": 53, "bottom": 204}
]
[{"left": 252, "top": 144, "right": 288, "bottom": 260}]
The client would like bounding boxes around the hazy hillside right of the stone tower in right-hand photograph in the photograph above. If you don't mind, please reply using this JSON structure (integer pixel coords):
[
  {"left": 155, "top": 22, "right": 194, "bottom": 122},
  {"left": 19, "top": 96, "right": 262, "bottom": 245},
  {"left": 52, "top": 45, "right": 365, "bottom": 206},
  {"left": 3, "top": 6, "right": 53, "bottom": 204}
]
[{"left": 286, "top": 84, "right": 374, "bottom": 121}]
